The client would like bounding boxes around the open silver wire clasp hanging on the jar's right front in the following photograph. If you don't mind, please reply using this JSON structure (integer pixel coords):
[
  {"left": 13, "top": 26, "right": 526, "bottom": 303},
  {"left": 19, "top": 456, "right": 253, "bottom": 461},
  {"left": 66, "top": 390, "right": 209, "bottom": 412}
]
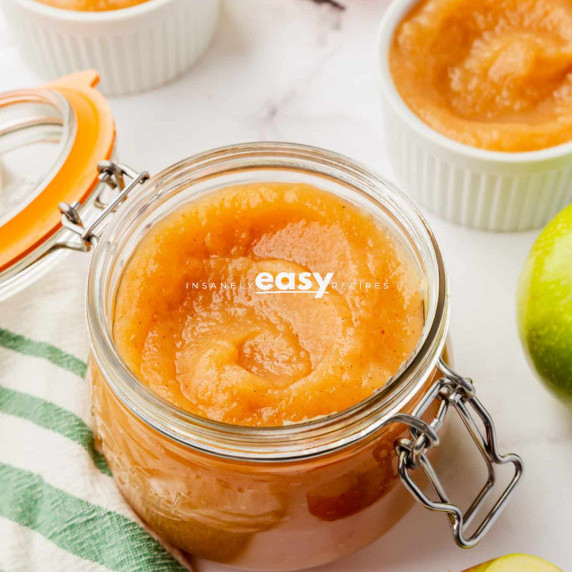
[{"left": 393, "top": 360, "right": 524, "bottom": 548}]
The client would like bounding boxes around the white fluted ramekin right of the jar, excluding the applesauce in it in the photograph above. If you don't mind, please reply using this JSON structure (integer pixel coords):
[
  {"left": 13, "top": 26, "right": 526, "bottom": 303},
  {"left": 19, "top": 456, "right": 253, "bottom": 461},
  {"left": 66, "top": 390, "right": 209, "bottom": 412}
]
[{"left": 377, "top": 0, "right": 572, "bottom": 231}]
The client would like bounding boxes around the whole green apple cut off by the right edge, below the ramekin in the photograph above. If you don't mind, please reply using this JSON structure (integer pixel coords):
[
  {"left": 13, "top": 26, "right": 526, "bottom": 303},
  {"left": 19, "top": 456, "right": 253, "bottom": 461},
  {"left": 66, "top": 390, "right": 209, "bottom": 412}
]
[{"left": 518, "top": 205, "right": 572, "bottom": 401}]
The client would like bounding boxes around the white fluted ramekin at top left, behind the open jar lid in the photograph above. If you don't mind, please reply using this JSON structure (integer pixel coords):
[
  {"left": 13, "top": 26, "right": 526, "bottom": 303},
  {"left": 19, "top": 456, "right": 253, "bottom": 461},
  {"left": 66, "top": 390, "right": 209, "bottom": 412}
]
[{"left": 1, "top": 0, "right": 220, "bottom": 95}]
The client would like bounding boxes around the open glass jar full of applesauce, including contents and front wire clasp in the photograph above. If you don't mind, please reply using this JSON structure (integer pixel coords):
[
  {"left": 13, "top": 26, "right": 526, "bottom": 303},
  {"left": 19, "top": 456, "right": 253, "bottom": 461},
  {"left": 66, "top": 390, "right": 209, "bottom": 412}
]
[{"left": 87, "top": 143, "right": 522, "bottom": 570}]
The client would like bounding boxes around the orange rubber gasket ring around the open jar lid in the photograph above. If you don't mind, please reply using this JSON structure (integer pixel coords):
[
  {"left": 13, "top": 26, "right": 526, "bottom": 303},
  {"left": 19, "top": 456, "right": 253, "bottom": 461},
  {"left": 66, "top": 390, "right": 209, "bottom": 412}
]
[{"left": 0, "top": 71, "right": 115, "bottom": 272}]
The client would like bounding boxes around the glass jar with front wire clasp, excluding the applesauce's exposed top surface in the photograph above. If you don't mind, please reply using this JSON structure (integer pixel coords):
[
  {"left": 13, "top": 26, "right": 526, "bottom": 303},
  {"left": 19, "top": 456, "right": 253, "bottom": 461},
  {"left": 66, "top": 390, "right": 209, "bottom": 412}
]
[{"left": 82, "top": 143, "right": 522, "bottom": 570}]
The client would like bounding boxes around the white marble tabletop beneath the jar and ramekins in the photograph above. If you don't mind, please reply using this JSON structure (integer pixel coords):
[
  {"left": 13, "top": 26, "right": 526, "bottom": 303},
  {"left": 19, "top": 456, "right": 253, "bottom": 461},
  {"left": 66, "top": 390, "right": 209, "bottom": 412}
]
[{"left": 0, "top": 0, "right": 572, "bottom": 572}]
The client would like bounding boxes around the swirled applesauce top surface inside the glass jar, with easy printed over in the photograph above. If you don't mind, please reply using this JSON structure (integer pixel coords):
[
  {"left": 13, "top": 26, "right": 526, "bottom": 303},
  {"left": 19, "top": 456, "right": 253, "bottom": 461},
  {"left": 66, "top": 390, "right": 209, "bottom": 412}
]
[{"left": 113, "top": 183, "right": 424, "bottom": 426}]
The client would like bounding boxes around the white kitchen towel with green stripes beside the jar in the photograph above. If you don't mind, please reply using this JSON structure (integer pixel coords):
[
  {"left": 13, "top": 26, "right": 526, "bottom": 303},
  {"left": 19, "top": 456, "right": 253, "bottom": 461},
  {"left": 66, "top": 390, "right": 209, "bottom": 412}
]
[{"left": 0, "top": 254, "right": 188, "bottom": 572}]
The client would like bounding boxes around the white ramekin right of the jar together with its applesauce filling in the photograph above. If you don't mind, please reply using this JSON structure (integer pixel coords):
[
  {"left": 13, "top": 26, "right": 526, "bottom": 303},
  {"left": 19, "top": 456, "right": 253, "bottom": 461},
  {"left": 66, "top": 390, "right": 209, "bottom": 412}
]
[{"left": 377, "top": 0, "right": 572, "bottom": 231}]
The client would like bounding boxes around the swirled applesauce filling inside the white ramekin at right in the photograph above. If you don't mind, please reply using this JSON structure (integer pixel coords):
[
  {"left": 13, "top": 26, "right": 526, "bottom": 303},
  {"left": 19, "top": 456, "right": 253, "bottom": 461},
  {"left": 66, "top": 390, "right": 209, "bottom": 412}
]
[{"left": 389, "top": 0, "right": 572, "bottom": 152}]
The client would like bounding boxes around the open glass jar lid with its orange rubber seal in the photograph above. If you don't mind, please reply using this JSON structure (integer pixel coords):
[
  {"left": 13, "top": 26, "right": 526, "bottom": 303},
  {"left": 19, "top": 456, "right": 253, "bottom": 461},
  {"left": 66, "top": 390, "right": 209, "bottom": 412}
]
[{"left": 0, "top": 71, "right": 115, "bottom": 298}]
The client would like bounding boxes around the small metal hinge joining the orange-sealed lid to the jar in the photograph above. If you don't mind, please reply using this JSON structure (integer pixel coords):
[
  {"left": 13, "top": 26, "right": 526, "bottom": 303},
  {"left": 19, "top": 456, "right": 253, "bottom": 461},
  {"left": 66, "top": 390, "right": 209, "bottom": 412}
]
[{"left": 57, "top": 161, "right": 149, "bottom": 252}]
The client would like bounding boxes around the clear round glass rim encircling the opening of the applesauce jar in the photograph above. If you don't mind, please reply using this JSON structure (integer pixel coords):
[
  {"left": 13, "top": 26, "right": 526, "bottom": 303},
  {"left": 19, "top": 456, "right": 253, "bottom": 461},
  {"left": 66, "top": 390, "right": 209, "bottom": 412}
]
[{"left": 86, "top": 142, "right": 449, "bottom": 462}]
